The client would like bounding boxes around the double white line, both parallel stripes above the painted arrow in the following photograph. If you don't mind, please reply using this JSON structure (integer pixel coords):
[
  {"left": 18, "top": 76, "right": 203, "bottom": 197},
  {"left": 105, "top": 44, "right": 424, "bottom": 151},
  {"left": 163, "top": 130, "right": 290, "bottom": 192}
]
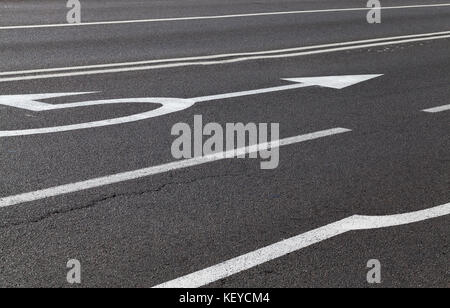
[{"left": 0, "top": 31, "right": 450, "bottom": 82}]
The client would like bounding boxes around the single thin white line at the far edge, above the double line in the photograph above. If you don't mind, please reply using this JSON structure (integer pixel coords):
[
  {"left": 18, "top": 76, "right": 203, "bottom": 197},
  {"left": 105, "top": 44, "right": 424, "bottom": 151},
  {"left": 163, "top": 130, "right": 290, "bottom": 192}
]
[{"left": 0, "top": 3, "right": 450, "bottom": 30}]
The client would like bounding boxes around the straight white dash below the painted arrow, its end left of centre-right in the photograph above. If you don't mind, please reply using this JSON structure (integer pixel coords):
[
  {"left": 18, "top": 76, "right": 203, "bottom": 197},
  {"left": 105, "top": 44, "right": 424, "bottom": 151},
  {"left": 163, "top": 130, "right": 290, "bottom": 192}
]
[{"left": 0, "top": 128, "right": 351, "bottom": 208}]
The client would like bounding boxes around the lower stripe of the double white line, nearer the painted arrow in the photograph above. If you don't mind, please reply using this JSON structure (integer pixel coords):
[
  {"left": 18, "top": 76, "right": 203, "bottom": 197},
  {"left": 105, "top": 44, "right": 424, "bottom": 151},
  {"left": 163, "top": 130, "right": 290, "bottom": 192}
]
[{"left": 0, "top": 34, "right": 450, "bottom": 82}]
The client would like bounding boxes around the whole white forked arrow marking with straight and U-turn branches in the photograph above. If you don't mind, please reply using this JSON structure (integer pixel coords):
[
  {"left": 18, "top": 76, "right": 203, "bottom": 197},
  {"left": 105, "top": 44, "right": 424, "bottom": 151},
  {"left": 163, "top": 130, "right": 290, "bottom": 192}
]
[{"left": 0, "top": 74, "right": 382, "bottom": 137}]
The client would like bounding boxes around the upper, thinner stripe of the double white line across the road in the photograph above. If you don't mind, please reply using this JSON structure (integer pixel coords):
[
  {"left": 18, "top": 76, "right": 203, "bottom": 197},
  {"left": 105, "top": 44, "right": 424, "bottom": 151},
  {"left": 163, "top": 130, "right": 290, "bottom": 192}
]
[{"left": 0, "top": 31, "right": 450, "bottom": 76}]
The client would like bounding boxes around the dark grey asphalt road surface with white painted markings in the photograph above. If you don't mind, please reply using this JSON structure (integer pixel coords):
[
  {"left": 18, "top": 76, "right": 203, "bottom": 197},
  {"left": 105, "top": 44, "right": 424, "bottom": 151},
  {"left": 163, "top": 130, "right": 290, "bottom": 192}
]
[{"left": 0, "top": 0, "right": 450, "bottom": 288}]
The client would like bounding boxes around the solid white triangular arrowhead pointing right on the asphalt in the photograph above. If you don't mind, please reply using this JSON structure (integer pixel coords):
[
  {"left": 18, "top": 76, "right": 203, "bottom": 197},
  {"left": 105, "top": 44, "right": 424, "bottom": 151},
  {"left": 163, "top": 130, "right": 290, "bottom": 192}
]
[{"left": 283, "top": 74, "right": 383, "bottom": 89}]
